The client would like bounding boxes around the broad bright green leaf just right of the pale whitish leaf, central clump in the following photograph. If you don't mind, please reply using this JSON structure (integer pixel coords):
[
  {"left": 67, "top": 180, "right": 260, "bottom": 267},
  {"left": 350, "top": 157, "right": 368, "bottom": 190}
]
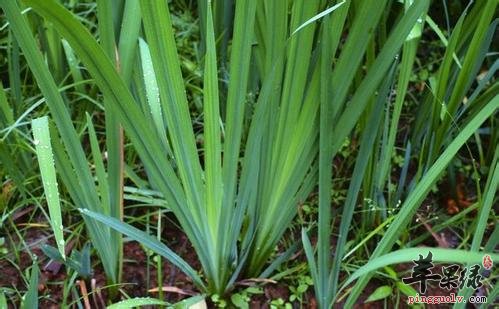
[{"left": 140, "top": 1, "right": 223, "bottom": 292}]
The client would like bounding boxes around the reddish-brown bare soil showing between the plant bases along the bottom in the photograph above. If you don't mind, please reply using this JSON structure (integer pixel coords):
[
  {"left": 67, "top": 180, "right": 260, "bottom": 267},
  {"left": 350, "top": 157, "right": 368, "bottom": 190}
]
[{"left": 0, "top": 199, "right": 492, "bottom": 308}]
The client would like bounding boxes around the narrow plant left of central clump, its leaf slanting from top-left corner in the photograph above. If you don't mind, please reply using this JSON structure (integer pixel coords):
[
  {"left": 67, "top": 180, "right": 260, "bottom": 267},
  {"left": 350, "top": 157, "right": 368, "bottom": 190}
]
[{"left": 0, "top": 1, "right": 121, "bottom": 281}]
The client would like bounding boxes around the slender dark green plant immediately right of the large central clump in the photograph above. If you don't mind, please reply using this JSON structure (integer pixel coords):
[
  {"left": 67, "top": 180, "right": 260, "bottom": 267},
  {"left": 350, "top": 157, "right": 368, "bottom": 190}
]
[{"left": 302, "top": 1, "right": 428, "bottom": 308}]
